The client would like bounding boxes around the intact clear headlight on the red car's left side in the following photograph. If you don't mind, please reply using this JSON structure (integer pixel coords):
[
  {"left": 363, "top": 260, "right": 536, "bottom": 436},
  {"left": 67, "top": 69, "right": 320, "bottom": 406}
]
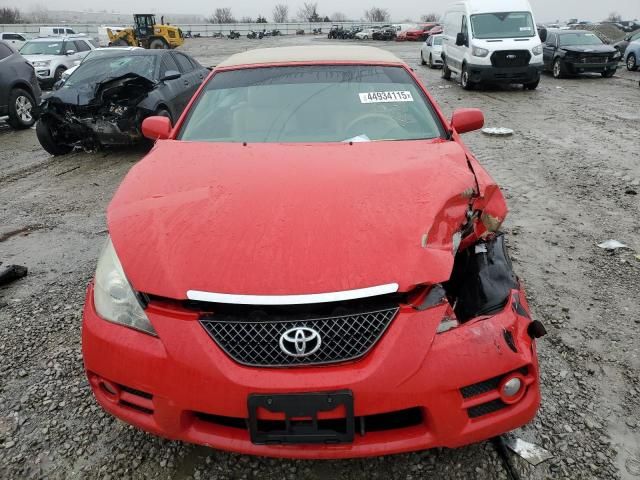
[{"left": 93, "top": 238, "right": 157, "bottom": 335}]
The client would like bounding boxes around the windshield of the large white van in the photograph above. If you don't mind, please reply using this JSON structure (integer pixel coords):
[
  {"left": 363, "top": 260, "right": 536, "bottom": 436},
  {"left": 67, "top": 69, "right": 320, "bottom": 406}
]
[{"left": 471, "top": 12, "right": 537, "bottom": 39}]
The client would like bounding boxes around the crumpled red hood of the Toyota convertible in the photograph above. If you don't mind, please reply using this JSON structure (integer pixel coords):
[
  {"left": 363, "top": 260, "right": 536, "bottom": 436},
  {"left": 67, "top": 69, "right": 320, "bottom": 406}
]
[{"left": 107, "top": 140, "right": 476, "bottom": 299}]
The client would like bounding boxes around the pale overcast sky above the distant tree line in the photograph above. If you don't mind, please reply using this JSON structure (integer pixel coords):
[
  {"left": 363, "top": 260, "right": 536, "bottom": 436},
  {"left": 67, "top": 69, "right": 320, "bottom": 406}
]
[{"left": 8, "top": 0, "right": 640, "bottom": 21}]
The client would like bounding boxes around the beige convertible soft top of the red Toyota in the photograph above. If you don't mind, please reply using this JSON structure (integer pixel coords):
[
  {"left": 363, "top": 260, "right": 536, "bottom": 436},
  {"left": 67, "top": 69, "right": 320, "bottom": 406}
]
[{"left": 218, "top": 45, "right": 403, "bottom": 67}]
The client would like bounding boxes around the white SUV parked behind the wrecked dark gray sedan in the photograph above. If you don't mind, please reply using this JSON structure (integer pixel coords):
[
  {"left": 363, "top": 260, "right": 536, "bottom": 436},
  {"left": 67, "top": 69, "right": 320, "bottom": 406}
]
[{"left": 20, "top": 37, "right": 96, "bottom": 86}]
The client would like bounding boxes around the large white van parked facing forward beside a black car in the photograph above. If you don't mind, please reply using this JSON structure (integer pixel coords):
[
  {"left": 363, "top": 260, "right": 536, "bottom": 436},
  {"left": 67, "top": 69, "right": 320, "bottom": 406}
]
[{"left": 442, "top": 0, "right": 543, "bottom": 90}]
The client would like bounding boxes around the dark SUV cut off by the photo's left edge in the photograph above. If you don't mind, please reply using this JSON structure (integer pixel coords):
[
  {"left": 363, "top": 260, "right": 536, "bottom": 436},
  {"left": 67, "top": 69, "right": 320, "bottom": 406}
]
[{"left": 0, "top": 41, "right": 41, "bottom": 128}]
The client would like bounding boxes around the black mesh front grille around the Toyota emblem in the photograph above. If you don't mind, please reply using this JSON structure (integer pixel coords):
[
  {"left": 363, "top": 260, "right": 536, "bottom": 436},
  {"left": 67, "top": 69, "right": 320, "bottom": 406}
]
[{"left": 200, "top": 306, "right": 398, "bottom": 367}]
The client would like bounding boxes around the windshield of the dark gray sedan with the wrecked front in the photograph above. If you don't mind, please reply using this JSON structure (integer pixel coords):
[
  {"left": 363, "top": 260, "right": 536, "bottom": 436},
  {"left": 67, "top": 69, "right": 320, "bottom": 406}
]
[{"left": 64, "top": 54, "right": 156, "bottom": 88}]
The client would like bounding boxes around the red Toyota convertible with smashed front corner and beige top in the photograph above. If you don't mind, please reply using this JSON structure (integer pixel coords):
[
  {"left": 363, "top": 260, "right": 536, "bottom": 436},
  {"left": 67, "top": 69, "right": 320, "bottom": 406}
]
[{"left": 82, "top": 46, "right": 544, "bottom": 458}]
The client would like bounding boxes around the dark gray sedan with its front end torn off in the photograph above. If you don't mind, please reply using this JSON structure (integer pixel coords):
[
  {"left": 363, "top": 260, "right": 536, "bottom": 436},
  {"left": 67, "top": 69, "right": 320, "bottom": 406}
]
[{"left": 36, "top": 50, "right": 209, "bottom": 155}]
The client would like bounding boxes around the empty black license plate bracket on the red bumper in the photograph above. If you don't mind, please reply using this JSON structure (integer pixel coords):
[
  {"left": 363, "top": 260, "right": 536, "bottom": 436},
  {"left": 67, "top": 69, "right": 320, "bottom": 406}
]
[{"left": 247, "top": 390, "right": 355, "bottom": 445}]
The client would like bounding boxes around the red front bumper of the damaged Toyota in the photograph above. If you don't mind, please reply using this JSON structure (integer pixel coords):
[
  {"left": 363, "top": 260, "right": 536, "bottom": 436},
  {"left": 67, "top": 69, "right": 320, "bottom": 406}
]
[{"left": 82, "top": 286, "right": 540, "bottom": 459}]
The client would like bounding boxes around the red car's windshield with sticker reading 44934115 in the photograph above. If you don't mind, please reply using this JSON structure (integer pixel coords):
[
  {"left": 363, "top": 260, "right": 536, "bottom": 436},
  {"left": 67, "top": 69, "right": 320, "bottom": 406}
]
[{"left": 178, "top": 65, "right": 444, "bottom": 143}]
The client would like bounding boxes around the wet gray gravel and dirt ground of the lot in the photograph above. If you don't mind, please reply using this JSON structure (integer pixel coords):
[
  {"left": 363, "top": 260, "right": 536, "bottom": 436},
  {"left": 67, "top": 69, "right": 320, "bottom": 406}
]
[{"left": 0, "top": 37, "right": 640, "bottom": 479}]
